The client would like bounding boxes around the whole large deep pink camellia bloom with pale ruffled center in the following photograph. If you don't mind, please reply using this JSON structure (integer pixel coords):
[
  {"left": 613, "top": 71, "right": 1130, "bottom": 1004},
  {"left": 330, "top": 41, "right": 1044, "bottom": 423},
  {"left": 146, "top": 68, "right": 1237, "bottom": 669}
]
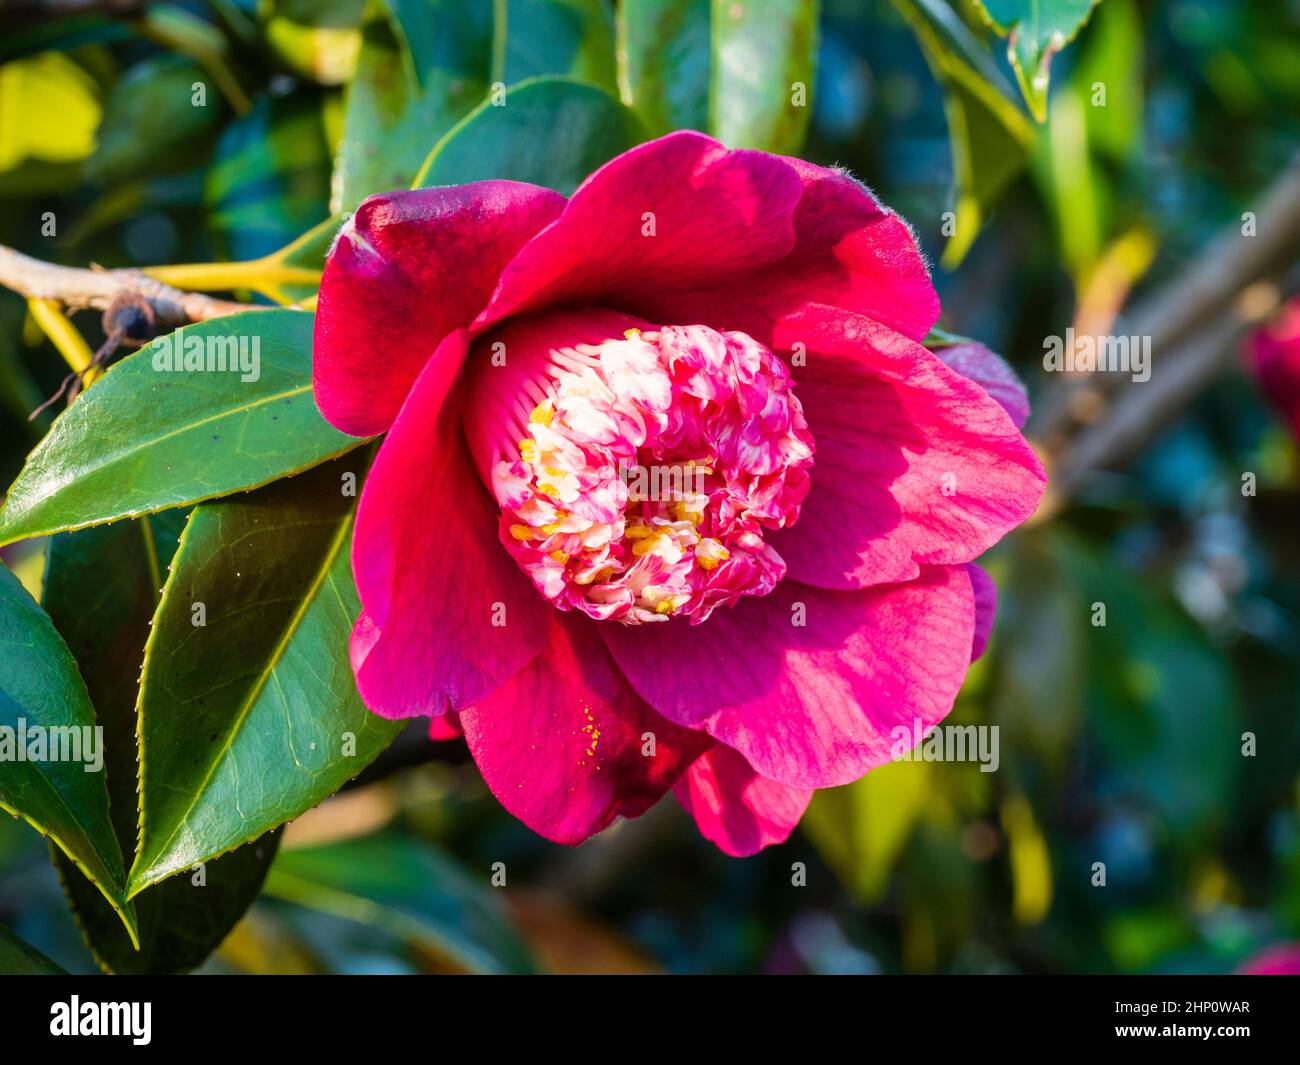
[{"left": 315, "top": 133, "right": 1044, "bottom": 854}]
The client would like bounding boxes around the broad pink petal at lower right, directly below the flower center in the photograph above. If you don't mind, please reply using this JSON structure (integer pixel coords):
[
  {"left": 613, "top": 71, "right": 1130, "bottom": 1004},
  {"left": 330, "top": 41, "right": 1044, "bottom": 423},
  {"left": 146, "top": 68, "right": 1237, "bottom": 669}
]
[{"left": 599, "top": 566, "right": 975, "bottom": 789}]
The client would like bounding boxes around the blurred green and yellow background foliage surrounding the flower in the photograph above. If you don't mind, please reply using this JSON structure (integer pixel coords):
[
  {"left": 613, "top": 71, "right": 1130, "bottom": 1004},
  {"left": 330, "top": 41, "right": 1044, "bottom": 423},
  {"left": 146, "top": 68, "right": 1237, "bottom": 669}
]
[{"left": 0, "top": 0, "right": 1300, "bottom": 973}]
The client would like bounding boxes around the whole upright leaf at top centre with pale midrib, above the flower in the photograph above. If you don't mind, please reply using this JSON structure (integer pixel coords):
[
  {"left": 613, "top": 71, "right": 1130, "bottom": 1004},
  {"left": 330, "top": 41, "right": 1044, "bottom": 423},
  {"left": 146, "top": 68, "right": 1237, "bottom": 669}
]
[{"left": 619, "top": 0, "right": 820, "bottom": 155}]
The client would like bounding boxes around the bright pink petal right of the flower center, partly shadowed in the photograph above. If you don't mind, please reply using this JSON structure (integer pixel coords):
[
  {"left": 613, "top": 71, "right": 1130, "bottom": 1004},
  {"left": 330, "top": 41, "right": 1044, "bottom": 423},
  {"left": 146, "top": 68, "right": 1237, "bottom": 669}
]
[{"left": 771, "top": 308, "right": 1047, "bottom": 589}]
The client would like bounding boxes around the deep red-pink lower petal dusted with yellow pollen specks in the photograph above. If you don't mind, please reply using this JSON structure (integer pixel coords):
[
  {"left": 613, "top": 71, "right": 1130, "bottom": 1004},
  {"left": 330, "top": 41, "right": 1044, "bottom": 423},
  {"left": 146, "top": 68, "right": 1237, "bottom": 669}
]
[{"left": 460, "top": 610, "right": 711, "bottom": 844}]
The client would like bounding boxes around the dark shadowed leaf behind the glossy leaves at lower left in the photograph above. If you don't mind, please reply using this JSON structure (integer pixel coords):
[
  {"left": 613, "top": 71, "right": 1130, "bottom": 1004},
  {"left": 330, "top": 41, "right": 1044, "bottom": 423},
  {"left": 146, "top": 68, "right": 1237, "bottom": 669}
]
[{"left": 44, "top": 511, "right": 278, "bottom": 974}]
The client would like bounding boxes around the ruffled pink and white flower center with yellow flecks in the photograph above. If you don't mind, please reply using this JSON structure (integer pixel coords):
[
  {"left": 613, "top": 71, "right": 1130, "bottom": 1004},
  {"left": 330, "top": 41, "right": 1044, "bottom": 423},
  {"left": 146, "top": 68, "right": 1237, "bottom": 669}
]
[{"left": 467, "top": 311, "right": 814, "bottom": 624}]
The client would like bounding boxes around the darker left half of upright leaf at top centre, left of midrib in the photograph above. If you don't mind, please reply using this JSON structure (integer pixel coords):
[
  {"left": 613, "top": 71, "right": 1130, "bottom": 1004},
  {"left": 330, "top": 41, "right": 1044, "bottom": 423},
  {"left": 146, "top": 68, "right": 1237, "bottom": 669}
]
[{"left": 618, "top": 0, "right": 712, "bottom": 137}]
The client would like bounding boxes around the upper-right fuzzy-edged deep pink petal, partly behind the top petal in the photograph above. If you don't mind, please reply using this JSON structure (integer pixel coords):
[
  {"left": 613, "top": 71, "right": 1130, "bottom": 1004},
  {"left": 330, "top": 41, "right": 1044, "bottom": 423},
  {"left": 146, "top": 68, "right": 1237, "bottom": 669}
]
[{"left": 636, "top": 159, "right": 939, "bottom": 342}]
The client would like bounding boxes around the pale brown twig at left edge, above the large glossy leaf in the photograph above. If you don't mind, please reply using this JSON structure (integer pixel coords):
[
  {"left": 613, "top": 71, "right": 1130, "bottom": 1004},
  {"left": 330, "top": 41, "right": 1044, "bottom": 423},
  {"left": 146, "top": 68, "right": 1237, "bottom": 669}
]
[{"left": 0, "top": 244, "right": 261, "bottom": 333}]
